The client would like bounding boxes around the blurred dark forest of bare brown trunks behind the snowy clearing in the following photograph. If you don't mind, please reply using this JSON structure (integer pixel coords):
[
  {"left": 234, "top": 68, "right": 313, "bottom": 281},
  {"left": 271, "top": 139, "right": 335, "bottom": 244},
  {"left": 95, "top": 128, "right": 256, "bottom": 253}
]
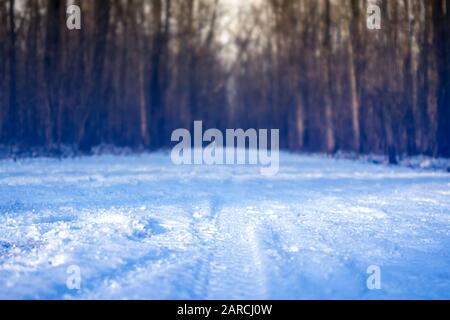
[{"left": 0, "top": 0, "right": 450, "bottom": 157}]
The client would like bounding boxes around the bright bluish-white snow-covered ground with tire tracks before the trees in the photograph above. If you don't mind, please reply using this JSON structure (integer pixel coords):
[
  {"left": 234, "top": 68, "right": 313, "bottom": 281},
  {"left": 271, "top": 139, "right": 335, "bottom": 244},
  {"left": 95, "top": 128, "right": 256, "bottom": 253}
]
[{"left": 0, "top": 153, "right": 450, "bottom": 299}]
